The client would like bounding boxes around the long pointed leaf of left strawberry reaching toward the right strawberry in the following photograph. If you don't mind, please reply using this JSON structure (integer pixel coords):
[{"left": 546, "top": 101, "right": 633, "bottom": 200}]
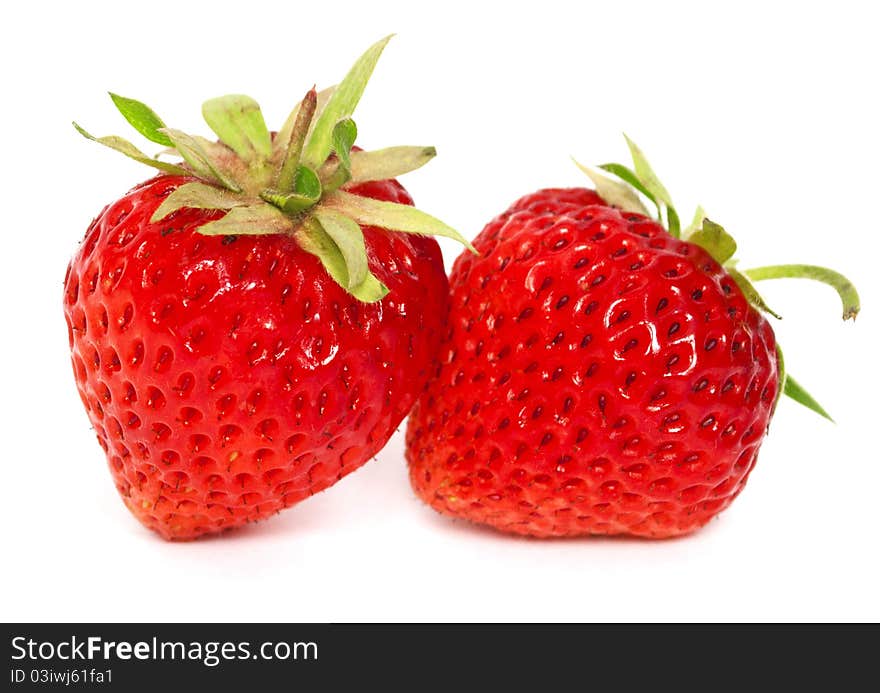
[{"left": 321, "top": 190, "right": 477, "bottom": 254}]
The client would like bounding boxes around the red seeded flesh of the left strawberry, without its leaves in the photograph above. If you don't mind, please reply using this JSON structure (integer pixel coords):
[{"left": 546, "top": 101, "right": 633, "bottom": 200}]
[{"left": 64, "top": 175, "right": 448, "bottom": 539}]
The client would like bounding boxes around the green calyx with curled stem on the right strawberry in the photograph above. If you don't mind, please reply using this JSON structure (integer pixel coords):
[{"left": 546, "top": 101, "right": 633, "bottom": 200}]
[{"left": 575, "top": 135, "right": 859, "bottom": 421}]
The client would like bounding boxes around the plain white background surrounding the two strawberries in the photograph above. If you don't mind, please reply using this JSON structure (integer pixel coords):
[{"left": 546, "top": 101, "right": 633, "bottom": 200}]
[{"left": 0, "top": 0, "right": 880, "bottom": 621}]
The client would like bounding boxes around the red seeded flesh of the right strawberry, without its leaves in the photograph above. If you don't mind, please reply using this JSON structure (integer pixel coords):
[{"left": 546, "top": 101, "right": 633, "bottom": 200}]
[{"left": 407, "top": 189, "right": 779, "bottom": 538}]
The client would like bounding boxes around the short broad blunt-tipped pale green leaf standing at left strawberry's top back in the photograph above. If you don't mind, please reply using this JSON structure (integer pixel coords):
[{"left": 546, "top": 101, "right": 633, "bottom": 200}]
[{"left": 202, "top": 94, "right": 272, "bottom": 163}]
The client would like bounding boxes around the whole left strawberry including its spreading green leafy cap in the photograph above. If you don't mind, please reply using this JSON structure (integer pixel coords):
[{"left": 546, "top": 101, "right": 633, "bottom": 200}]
[{"left": 64, "top": 39, "right": 470, "bottom": 539}]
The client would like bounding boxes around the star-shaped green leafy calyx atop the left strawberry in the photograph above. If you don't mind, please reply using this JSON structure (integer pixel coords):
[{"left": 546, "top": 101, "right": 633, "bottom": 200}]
[{"left": 74, "top": 36, "right": 473, "bottom": 303}]
